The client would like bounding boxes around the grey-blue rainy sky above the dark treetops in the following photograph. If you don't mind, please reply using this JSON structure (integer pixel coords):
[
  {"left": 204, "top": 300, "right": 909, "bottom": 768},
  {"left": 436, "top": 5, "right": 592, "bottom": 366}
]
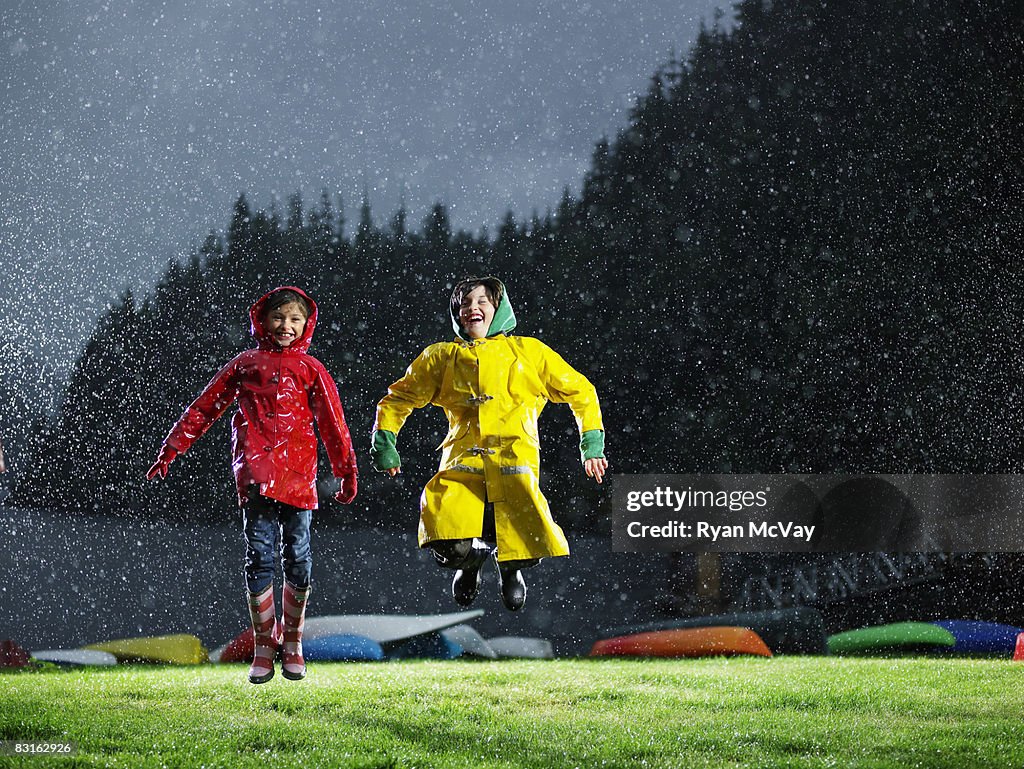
[{"left": 0, "top": 0, "right": 718, "bottom": 387}]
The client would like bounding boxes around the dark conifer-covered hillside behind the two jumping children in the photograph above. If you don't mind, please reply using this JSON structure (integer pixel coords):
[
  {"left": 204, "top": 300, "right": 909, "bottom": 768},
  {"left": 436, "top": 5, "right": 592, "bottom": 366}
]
[{"left": 17, "top": 0, "right": 1024, "bottom": 528}]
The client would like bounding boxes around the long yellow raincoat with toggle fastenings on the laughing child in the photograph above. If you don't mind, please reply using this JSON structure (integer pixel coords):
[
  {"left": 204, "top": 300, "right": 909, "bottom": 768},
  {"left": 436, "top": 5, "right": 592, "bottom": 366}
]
[{"left": 374, "top": 286, "right": 604, "bottom": 561}]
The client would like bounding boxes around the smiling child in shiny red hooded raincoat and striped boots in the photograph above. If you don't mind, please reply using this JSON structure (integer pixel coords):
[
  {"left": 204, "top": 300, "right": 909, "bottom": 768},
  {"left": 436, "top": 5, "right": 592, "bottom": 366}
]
[{"left": 146, "top": 286, "right": 356, "bottom": 684}]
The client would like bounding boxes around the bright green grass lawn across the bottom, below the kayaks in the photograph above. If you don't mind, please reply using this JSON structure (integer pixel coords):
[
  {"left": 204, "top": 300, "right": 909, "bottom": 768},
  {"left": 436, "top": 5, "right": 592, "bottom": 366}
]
[{"left": 0, "top": 657, "right": 1024, "bottom": 769}]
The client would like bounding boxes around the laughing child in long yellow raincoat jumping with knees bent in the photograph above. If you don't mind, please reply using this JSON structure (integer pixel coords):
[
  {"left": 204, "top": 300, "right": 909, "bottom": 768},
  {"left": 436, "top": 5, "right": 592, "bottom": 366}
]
[{"left": 370, "top": 277, "right": 608, "bottom": 611}]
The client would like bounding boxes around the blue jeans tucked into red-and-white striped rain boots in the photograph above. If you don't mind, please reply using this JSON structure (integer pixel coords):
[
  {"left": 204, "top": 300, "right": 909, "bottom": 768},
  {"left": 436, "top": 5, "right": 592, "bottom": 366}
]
[{"left": 242, "top": 486, "right": 313, "bottom": 593}]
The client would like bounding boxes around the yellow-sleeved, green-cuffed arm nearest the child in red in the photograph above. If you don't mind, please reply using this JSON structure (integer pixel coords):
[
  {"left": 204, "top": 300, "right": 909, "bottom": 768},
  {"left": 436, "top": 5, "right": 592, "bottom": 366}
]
[{"left": 370, "top": 345, "right": 446, "bottom": 477}]
